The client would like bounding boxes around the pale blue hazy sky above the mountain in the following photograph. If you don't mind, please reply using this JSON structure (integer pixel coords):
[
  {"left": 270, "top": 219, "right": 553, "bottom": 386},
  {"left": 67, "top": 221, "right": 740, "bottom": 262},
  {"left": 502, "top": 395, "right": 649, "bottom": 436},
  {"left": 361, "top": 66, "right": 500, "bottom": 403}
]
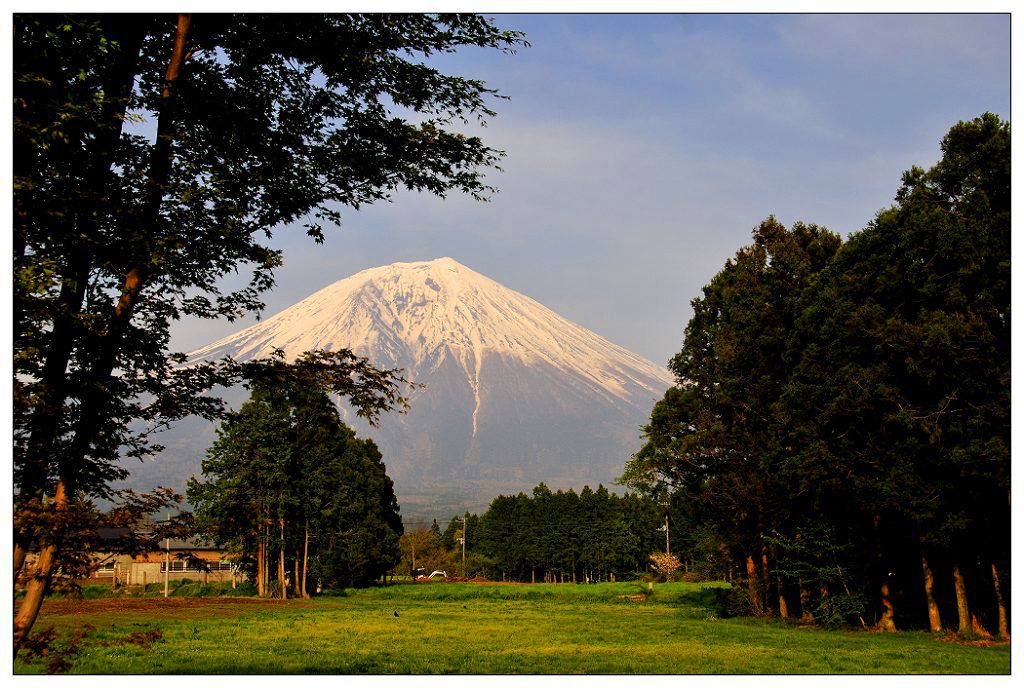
[{"left": 172, "top": 14, "right": 1010, "bottom": 366}]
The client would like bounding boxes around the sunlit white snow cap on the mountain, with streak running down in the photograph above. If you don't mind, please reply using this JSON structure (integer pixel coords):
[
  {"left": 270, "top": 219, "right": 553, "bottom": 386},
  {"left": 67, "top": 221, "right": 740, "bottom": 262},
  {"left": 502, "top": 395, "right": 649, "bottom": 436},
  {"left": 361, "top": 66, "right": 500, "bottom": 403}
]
[{"left": 190, "top": 256, "right": 672, "bottom": 409}]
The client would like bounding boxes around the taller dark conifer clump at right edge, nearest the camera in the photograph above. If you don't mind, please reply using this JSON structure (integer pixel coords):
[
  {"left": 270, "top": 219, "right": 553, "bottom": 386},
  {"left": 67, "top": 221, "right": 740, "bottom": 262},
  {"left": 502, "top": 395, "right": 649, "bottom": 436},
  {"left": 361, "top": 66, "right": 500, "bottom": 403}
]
[{"left": 785, "top": 114, "right": 1010, "bottom": 634}]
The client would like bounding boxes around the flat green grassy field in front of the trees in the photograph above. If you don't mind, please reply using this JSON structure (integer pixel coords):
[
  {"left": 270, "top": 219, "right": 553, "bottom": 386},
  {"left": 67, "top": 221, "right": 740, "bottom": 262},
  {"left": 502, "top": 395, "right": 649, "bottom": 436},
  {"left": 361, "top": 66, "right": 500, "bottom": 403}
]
[{"left": 15, "top": 583, "right": 1010, "bottom": 674}]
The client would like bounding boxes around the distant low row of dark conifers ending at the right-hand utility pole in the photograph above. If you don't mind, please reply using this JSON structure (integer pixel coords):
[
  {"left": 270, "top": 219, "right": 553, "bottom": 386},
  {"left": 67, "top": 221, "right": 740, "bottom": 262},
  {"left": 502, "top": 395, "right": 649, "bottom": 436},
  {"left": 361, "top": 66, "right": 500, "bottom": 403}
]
[{"left": 402, "top": 483, "right": 665, "bottom": 583}]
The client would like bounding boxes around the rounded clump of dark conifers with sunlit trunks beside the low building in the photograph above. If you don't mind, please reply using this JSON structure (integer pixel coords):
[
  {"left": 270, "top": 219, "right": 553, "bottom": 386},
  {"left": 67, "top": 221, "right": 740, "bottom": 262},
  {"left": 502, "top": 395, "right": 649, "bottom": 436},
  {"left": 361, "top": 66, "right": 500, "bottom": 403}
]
[{"left": 187, "top": 384, "right": 402, "bottom": 598}]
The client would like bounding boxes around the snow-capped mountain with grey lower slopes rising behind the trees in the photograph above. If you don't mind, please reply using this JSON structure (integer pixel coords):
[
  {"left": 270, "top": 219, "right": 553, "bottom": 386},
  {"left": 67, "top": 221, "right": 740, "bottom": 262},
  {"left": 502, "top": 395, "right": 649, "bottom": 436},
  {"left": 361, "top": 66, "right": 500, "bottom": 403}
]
[{"left": 157, "top": 258, "right": 673, "bottom": 513}]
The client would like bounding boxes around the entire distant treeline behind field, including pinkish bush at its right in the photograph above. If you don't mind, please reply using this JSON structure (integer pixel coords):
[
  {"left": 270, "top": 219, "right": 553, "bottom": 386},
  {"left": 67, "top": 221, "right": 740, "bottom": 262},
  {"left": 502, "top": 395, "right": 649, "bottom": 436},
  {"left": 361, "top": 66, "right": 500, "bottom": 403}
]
[{"left": 391, "top": 483, "right": 749, "bottom": 583}]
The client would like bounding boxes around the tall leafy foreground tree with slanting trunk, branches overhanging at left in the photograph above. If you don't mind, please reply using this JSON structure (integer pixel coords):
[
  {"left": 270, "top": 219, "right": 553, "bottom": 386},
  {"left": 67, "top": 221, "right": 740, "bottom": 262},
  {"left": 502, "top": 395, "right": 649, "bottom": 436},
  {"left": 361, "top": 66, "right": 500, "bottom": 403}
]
[{"left": 13, "top": 14, "right": 523, "bottom": 643}]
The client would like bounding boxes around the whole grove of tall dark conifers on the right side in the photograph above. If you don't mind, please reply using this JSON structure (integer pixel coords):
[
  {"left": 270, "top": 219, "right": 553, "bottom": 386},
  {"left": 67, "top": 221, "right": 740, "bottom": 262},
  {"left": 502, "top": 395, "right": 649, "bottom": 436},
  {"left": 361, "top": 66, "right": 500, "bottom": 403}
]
[{"left": 624, "top": 114, "right": 1011, "bottom": 637}]
